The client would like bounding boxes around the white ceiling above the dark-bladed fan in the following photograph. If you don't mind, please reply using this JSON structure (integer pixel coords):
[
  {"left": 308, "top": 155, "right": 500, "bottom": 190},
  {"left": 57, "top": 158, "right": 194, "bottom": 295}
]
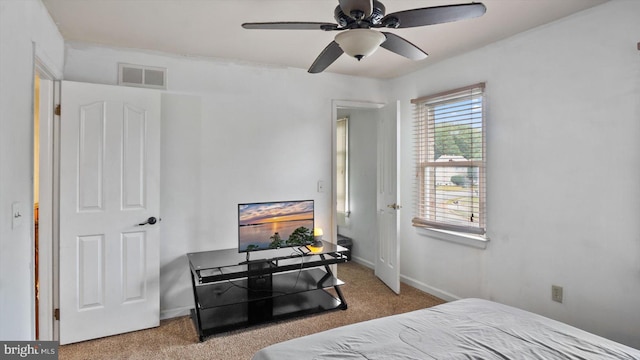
[{"left": 43, "top": 0, "right": 608, "bottom": 78}]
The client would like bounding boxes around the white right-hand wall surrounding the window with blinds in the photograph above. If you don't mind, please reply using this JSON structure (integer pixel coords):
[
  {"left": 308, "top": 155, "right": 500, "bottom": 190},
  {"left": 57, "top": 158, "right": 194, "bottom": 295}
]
[{"left": 393, "top": 0, "right": 640, "bottom": 348}]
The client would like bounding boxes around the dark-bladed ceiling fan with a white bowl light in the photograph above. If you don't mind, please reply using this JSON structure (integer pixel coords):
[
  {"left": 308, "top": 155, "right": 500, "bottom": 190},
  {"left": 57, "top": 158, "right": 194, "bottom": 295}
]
[{"left": 242, "top": 0, "right": 487, "bottom": 73}]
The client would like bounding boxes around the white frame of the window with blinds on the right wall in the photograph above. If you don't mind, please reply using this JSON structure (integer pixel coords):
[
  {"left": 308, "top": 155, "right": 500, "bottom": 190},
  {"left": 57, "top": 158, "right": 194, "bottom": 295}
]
[{"left": 411, "top": 83, "right": 487, "bottom": 240}]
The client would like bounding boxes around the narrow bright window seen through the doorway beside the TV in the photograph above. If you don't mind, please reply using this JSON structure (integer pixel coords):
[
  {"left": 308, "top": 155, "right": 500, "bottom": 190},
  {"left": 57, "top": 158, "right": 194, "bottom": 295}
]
[{"left": 336, "top": 118, "right": 349, "bottom": 219}]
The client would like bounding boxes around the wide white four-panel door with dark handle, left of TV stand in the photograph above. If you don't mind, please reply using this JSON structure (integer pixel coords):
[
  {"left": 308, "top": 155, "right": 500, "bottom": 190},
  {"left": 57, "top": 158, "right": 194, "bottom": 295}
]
[{"left": 60, "top": 81, "right": 160, "bottom": 344}]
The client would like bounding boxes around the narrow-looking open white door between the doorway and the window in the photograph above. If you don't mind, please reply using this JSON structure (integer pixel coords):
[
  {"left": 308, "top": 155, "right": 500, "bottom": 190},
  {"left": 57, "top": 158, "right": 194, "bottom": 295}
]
[{"left": 375, "top": 103, "right": 400, "bottom": 294}]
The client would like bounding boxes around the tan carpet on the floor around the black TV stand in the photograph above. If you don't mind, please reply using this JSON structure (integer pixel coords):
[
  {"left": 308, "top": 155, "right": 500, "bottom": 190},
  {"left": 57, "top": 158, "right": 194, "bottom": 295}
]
[{"left": 59, "top": 262, "right": 444, "bottom": 360}]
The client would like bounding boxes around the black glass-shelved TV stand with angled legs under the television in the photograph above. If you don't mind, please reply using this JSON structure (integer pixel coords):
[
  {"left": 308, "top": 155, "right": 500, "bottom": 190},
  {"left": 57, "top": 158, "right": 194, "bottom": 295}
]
[{"left": 187, "top": 242, "right": 348, "bottom": 341}]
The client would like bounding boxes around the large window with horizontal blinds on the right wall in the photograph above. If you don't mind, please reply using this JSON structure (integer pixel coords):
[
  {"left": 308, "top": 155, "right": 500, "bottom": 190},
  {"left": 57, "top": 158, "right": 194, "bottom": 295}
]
[{"left": 411, "top": 83, "right": 486, "bottom": 235}]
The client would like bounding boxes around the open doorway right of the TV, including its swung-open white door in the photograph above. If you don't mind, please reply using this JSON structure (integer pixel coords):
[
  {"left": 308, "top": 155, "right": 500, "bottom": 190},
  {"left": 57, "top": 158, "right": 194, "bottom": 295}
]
[{"left": 332, "top": 101, "right": 401, "bottom": 293}]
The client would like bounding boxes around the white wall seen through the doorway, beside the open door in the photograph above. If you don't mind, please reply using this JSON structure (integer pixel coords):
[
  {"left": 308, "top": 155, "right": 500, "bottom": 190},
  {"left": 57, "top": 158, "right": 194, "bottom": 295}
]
[{"left": 338, "top": 108, "right": 380, "bottom": 267}]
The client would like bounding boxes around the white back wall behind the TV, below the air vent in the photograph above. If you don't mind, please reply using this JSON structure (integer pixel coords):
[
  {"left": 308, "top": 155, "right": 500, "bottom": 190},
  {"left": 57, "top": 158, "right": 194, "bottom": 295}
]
[{"left": 63, "top": 44, "right": 385, "bottom": 317}]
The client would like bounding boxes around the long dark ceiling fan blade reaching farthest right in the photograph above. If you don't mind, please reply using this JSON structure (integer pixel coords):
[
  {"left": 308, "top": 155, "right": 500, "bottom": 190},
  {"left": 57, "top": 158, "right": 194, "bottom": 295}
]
[{"left": 382, "top": 3, "right": 487, "bottom": 28}]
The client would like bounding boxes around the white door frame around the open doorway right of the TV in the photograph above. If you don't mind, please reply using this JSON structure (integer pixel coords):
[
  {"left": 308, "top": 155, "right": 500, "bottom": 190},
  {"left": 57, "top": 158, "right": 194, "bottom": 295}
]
[{"left": 331, "top": 99, "right": 386, "bottom": 255}]
